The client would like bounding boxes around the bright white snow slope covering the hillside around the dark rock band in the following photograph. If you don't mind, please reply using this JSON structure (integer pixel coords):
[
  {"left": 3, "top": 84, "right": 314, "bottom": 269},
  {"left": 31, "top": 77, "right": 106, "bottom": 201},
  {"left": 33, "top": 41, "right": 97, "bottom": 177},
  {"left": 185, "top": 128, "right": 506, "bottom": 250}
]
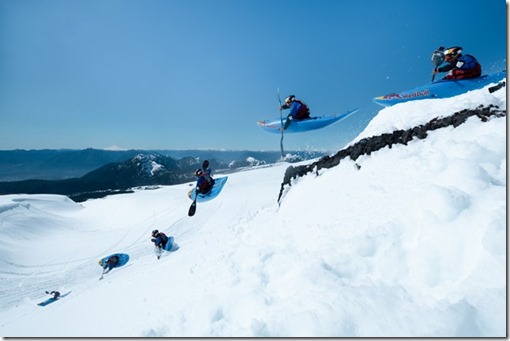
[{"left": 0, "top": 79, "right": 506, "bottom": 337}]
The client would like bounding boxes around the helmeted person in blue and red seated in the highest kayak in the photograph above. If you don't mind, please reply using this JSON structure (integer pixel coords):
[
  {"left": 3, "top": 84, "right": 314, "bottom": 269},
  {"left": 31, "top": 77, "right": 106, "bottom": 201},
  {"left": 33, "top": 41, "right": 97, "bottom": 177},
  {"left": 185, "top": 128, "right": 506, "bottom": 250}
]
[{"left": 432, "top": 46, "right": 482, "bottom": 79}]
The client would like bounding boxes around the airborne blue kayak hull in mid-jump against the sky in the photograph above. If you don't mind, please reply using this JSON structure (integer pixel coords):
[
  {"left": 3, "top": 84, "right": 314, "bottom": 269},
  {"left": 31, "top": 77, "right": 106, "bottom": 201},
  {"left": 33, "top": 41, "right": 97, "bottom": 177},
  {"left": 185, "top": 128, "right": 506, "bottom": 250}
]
[{"left": 257, "top": 108, "right": 359, "bottom": 134}]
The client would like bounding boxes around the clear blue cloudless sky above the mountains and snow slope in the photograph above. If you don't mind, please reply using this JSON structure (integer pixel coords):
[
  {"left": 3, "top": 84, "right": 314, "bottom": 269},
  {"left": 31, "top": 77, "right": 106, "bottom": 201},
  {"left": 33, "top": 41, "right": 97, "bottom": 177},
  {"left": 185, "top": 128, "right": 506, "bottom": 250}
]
[{"left": 0, "top": 0, "right": 507, "bottom": 151}]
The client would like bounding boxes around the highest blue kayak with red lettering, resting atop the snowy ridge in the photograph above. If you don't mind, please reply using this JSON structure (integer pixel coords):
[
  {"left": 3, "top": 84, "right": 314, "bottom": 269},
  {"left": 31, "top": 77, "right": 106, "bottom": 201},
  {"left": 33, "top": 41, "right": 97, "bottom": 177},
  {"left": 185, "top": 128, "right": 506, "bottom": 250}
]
[{"left": 373, "top": 70, "right": 506, "bottom": 107}]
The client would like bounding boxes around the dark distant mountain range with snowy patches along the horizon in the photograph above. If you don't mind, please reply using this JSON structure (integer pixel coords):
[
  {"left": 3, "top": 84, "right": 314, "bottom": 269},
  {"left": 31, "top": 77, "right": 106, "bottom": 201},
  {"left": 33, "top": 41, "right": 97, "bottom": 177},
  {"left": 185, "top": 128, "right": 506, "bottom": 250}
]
[{"left": 0, "top": 149, "right": 324, "bottom": 201}]
